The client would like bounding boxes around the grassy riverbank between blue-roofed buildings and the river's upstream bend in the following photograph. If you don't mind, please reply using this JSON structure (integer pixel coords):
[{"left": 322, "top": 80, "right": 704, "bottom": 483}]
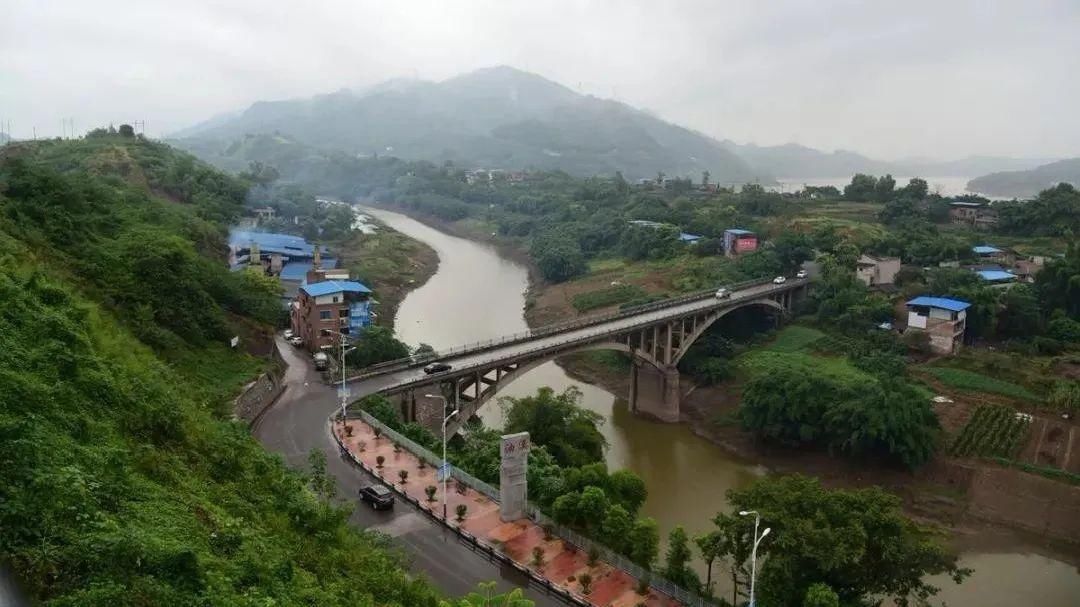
[{"left": 336, "top": 213, "right": 438, "bottom": 329}]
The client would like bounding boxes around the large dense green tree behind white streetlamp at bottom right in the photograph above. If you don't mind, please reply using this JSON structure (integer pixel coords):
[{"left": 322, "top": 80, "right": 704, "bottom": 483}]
[{"left": 729, "top": 476, "right": 970, "bottom": 605}]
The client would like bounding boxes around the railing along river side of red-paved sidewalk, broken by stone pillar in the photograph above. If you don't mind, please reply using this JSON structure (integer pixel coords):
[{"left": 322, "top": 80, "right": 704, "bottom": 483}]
[{"left": 347, "top": 409, "right": 715, "bottom": 607}]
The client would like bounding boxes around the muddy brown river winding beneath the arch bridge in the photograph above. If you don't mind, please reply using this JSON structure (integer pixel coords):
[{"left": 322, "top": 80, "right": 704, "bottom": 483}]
[{"left": 367, "top": 205, "right": 1080, "bottom": 607}]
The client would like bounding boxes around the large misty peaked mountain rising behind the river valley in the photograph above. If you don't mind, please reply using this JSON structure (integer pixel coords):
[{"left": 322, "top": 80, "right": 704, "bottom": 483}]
[{"left": 174, "top": 67, "right": 771, "bottom": 184}]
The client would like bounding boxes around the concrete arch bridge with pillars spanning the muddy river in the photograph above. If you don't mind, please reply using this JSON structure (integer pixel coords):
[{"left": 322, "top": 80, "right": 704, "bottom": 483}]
[{"left": 349, "top": 279, "right": 809, "bottom": 433}]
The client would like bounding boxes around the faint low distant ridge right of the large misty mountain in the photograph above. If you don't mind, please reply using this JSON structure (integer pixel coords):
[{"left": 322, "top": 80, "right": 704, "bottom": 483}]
[{"left": 723, "top": 140, "right": 1049, "bottom": 179}]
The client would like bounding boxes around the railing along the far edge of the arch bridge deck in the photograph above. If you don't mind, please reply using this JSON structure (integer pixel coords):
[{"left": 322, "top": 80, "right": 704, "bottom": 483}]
[{"left": 347, "top": 274, "right": 771, "bottom": 381}]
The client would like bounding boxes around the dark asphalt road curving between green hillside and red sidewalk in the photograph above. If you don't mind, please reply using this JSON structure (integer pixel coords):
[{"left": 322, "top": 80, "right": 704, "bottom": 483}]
[{"left": 254, "top": 339, "right": 564, "bottom": 607}]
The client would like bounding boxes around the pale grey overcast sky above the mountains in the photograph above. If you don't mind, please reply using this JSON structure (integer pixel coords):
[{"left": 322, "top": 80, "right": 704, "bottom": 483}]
[{"left": 6, "top": 0, "right": 1080, "bottom": 158}]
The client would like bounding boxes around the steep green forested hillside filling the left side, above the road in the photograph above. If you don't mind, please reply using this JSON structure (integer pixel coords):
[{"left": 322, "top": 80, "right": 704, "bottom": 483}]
[{"left": 0, "top": 131, "right": 437, "bottom": 606}]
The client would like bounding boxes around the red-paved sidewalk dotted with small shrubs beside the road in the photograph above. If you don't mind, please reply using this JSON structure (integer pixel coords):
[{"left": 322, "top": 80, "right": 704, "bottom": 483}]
[{"left": 334, "top": 419, "right": 679, "bottom": 607}]
